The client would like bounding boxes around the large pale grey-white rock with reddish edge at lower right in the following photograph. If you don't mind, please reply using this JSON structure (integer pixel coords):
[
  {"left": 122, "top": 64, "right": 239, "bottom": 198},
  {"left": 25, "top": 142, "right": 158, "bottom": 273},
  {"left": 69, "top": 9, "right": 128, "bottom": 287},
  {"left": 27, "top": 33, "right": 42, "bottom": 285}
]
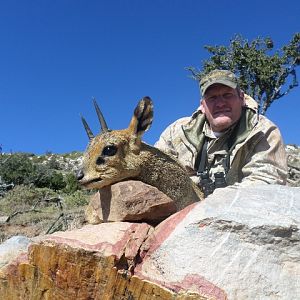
[{"left": 135, "top": 185, "right": 300, "bottom": 300}]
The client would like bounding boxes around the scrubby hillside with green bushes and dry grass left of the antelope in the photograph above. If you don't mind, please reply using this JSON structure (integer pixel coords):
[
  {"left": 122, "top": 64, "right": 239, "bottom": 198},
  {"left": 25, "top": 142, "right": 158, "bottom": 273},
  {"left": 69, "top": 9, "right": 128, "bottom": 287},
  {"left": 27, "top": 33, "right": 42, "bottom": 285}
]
[{"left": 0, "top": 152, "right": 90, "bottom": 242}]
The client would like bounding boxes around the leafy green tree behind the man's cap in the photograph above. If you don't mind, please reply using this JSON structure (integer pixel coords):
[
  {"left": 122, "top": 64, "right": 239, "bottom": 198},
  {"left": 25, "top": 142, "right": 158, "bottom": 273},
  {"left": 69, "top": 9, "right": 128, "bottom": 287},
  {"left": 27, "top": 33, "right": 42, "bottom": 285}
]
[{"left": 188, "top": 33, "right": 300, "bottom": 114}]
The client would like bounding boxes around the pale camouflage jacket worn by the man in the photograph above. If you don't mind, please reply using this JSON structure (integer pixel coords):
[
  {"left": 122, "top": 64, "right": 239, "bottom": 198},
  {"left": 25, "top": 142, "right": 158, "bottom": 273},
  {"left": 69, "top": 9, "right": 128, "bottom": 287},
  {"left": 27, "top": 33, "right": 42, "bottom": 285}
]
[{"left": 154, "top": 95, "right": 287, "bottom": 185}]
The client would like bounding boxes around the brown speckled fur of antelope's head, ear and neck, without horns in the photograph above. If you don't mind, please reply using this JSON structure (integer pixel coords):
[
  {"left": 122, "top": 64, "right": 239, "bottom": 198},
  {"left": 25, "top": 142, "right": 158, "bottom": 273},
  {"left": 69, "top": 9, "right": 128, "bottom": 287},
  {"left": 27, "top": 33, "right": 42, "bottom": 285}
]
[{"left": 79, "top": 97, "right": 203, "bottom": 209}]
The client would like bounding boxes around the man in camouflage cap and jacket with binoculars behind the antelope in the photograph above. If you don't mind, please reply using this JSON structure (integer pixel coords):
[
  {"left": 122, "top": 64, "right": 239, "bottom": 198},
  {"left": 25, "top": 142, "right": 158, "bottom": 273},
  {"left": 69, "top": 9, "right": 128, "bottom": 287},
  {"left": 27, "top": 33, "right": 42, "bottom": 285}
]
[{"left": 155, "top": 70, "right": 287, "bottom": 196}]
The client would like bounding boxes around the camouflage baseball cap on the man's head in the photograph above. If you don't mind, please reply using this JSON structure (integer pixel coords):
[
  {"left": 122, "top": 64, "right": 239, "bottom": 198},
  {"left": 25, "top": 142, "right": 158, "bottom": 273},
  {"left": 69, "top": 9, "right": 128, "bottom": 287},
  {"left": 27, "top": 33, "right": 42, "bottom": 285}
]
[{"left": 200, "top": 70, "right": 238, "bottom": 96}]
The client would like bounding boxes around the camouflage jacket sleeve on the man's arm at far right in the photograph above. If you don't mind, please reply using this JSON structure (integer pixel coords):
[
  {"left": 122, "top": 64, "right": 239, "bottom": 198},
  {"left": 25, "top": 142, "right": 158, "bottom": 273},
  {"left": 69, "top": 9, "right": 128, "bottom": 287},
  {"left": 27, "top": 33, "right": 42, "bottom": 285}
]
[{"left": 240, "top": 122, "right": 288, "bottom": 185}]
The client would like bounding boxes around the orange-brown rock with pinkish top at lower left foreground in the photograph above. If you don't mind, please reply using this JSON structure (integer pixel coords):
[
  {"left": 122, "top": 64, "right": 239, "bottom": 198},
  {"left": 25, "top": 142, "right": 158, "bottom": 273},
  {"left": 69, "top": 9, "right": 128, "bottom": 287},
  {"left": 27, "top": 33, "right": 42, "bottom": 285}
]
[{"left": 0, "top": 222, "right": 225, "bottom": 300}]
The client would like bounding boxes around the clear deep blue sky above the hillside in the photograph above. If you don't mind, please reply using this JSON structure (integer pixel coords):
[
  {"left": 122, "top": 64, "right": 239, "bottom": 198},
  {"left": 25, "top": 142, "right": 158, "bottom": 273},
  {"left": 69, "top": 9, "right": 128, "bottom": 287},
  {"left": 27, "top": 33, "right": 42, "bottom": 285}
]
[{"left": 0, "top": 0, "right": 300, "bottom": 154}]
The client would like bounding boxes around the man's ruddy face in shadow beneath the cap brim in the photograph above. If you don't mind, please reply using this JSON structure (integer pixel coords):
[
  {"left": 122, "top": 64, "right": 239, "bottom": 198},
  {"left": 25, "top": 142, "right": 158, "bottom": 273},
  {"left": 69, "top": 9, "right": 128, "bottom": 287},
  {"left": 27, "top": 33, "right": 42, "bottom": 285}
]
[{"left": 200, "top": 83, "right": 244, "bottom": 132}]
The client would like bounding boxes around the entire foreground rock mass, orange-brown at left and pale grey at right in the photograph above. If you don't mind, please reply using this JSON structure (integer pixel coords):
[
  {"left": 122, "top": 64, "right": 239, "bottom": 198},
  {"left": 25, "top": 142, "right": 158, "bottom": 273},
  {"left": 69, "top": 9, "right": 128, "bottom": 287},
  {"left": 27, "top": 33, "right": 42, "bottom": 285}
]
[{"left": 0, "top": 185, "right": 300, "bottom": 300}]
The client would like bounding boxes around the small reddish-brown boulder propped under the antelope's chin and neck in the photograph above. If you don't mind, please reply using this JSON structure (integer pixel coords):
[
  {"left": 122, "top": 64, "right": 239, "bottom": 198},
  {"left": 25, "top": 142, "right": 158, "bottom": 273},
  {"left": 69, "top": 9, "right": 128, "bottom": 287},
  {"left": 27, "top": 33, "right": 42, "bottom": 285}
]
[{"left": 85, "top": 180, "right": 176, "bottom": 224}]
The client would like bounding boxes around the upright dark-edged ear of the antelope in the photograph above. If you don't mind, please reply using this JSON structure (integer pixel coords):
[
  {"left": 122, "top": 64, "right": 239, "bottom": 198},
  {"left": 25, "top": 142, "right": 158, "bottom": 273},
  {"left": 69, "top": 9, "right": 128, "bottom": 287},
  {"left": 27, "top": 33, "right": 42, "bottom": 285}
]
[{"left": 128, "top": 97, "right": 153, "bottom": 153}]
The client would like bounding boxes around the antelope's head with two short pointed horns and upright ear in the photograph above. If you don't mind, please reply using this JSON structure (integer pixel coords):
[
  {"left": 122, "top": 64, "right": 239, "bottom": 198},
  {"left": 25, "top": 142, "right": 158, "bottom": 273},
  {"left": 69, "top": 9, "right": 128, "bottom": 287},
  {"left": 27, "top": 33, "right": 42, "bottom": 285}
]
[{"left": 77, "top": 97, "right": 153, "bottom": 189}]
